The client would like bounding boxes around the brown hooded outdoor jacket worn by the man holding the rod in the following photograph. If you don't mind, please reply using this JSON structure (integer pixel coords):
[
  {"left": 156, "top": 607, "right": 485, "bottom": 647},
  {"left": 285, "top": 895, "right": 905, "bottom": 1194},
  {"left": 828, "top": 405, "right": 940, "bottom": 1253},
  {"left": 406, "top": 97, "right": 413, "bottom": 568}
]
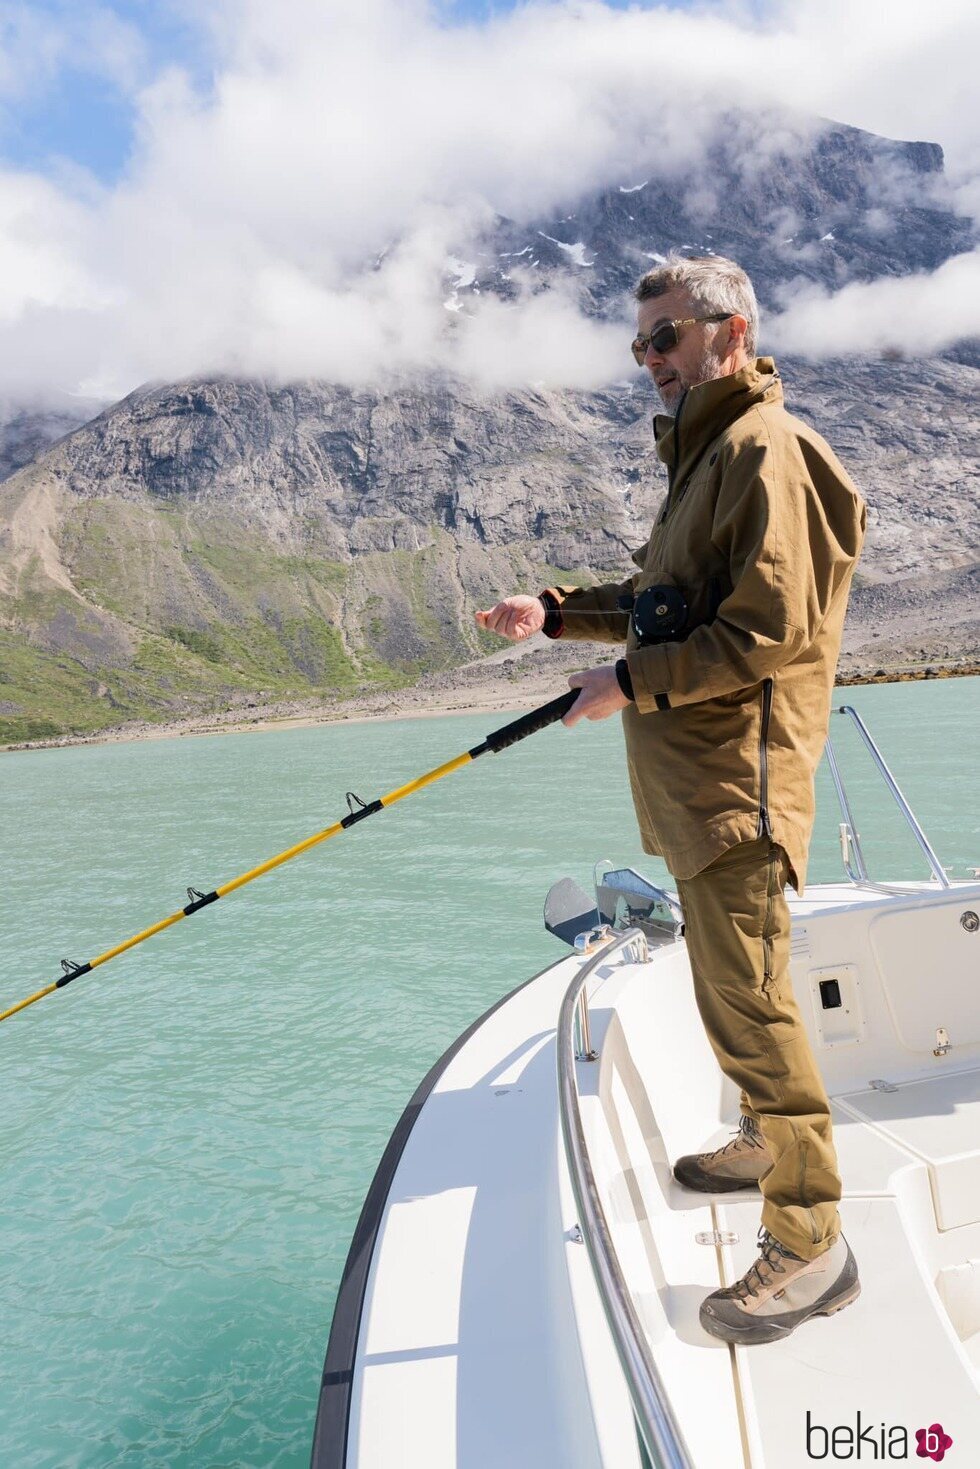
[{"left": 552, "top": 357, "right": 865, "bottom": 892}]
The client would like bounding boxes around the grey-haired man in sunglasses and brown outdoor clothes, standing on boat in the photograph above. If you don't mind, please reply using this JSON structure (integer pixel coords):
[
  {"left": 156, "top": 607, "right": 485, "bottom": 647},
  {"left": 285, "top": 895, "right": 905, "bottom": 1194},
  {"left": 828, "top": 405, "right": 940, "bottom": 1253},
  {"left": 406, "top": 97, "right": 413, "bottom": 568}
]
[{"left": 476, "top": 256, "right": 865, "bottom": 1343}]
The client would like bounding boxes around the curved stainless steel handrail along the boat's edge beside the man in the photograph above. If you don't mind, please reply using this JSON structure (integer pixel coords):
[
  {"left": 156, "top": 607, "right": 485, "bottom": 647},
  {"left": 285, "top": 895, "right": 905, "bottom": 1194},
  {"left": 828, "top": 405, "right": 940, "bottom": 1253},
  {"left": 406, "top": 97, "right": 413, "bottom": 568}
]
[{"left": 557, "top": 928, "right": 693, "bottom": 1469}]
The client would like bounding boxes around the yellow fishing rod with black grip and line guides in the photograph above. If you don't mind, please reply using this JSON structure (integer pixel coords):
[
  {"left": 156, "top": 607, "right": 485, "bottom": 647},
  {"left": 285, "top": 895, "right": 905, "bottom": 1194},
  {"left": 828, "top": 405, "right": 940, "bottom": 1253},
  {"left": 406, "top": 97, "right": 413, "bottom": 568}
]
[{"left": 0, "top": 689, "right": 580, "bottom": 1021}]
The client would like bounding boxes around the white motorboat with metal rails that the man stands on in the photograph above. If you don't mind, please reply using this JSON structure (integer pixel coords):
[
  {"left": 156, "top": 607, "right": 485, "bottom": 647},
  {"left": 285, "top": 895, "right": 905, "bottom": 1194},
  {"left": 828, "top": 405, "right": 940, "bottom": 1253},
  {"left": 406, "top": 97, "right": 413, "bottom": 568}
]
[{"left": 311, "top": 708, "right": 980, "bottom": 1469}]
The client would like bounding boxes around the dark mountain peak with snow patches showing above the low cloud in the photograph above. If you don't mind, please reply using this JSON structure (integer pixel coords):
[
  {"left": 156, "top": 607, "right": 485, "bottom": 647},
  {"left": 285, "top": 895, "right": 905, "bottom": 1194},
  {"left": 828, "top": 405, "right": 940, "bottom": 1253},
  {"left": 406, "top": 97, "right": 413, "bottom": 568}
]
[{"left": 447, "top": 113, "right": 976, "bottom": 314}]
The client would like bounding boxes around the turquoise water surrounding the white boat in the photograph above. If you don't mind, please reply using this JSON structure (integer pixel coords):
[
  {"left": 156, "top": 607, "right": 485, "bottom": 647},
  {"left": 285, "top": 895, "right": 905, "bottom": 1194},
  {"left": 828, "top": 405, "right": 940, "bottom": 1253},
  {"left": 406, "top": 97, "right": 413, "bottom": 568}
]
[{"left": 0, "top": 679, "right": 980, "bottom": 1469}]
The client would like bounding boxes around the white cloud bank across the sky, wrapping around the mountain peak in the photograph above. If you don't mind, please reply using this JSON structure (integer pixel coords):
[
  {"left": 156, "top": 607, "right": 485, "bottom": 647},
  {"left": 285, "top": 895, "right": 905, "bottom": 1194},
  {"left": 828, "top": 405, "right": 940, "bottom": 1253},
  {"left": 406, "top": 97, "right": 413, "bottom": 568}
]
[{"left": 0, "top": 0, "right": 980, "bottom": 395}]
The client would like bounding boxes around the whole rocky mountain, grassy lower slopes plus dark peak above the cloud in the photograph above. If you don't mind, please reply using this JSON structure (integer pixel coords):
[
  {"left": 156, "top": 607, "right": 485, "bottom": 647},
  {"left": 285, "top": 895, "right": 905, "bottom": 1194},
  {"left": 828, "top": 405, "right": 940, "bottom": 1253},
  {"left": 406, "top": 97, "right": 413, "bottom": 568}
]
[{"left": 0, "top": 111, "right": 980, "bottom": 740}]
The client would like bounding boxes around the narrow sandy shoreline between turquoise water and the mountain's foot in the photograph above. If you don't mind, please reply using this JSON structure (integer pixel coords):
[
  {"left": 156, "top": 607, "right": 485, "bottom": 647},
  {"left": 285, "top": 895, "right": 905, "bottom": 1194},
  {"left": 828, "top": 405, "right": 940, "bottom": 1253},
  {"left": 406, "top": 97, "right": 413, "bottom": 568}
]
[{"left": 0, "top": 660, "right": 980, "bottom": 754}]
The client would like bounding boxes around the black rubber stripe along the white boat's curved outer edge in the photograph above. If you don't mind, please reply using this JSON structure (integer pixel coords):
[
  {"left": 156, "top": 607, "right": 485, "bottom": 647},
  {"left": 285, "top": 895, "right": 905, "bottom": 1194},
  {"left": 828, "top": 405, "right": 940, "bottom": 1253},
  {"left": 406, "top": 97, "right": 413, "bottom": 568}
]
[{"left": 310, "top": 950, "right": 570, "bottom": 1469}]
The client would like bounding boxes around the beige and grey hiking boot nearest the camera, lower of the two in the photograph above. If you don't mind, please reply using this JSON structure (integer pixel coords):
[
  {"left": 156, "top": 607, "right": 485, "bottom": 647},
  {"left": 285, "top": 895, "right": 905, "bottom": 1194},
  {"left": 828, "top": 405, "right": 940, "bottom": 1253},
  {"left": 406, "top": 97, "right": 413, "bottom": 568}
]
[{"left": 701, "top": 1230, "right": 861, "bottom": 1346}]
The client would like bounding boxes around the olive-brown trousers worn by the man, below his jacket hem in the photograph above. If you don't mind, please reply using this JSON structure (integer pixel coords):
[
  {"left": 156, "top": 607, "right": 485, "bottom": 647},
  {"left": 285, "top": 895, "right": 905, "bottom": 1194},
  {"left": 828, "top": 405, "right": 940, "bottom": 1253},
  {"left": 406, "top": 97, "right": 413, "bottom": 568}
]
[{"left": 677, "top": 837, "right": 840, "bottom": 1260}]
